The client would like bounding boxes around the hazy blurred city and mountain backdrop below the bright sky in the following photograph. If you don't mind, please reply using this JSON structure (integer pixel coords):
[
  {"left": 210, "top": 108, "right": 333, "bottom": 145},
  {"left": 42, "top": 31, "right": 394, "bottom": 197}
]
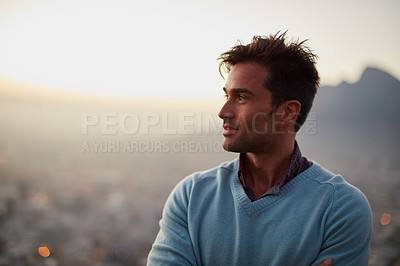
[{"left": 0, "top": 68, "right": 400, "bottom": 265}]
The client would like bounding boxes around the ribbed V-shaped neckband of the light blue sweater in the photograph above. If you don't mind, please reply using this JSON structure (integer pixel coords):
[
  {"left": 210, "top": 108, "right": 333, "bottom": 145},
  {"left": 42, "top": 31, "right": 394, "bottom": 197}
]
[{"left": 231, "top": 159, "right": 321, "bottom": 216}]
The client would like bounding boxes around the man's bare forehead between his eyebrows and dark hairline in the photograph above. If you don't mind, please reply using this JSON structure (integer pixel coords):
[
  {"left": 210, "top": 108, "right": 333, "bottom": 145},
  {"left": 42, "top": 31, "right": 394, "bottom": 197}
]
[{"left": 225, "top": 63, "right": 268, "bottom": 90}]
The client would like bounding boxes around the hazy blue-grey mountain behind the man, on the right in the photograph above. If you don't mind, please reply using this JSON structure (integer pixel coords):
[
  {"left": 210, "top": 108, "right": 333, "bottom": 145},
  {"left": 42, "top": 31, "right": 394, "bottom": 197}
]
[{"left": 300, "top": 67, "right": 400, "bottom": 165}]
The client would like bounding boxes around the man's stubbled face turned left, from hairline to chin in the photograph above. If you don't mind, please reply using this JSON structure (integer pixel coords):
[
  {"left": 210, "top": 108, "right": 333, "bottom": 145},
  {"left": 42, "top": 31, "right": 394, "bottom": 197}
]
[{"left": 218, "top": 63, "right": 274, "bottom": 153}]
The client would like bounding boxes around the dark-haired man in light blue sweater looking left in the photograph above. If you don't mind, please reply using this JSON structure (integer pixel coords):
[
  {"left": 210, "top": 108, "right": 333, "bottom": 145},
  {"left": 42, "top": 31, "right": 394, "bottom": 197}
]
[{"left": 148, "top": 34, "right": 372, "bottom": 266}]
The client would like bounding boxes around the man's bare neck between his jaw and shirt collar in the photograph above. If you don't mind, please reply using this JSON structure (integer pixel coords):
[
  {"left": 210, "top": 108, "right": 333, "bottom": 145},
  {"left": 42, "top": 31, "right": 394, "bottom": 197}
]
[{"left": 245, "top": 139, "right": 294, "bottom": 199}]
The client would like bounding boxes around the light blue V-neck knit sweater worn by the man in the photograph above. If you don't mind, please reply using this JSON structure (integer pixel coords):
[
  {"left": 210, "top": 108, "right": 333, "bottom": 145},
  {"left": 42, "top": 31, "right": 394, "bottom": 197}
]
[{"left": 147, "top": 159, "right": 372, "bottom": 266}]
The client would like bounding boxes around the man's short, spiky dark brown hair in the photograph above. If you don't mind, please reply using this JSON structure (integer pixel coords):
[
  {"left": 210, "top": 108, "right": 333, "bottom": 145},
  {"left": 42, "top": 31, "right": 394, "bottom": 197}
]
[{"left": 219, "top": 32, "right": 319, "bottom": 131}]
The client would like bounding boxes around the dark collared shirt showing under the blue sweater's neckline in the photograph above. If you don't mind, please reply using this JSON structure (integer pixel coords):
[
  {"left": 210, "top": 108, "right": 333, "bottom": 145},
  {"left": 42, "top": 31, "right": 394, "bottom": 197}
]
[{"left": 238, "top": 141, "right": 312, "bottom": 201}]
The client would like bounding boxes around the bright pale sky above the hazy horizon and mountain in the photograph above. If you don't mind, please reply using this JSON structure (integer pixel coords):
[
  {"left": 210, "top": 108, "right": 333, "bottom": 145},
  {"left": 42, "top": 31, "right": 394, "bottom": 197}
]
[{"left": 0, "top": 0, "right": 400, "bottom": 98}]
